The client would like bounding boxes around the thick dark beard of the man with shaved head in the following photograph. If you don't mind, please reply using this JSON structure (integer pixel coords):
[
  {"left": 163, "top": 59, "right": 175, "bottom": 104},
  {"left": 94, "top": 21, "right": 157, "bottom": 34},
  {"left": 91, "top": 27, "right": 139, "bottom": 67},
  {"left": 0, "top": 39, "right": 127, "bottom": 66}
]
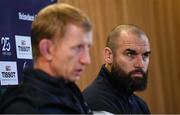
[{"left": 110, "top": 63, "right": 148, "bottom": 93}]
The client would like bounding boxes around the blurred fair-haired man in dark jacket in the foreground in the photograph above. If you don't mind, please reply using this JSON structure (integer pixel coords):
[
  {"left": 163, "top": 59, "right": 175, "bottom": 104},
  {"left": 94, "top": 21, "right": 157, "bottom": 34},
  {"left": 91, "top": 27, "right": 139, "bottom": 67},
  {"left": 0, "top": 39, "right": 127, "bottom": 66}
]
[{"left": 0, "top": 4, "right": 92, "bottom": 114}]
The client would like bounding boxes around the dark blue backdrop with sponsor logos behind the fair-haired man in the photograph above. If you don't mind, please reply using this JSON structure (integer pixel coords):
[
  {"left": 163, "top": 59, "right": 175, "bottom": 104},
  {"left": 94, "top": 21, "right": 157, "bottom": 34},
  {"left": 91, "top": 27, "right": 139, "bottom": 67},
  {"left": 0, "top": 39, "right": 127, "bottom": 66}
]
[{"left": 0, "top": 0, "right": 56, "bottom": 86}]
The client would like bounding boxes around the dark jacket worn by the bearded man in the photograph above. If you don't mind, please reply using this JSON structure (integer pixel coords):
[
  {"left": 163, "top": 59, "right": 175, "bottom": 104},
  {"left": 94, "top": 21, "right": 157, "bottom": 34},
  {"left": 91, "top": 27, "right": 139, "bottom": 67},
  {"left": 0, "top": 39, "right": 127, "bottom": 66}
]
[{"left": 83, "top": 65, "right": 150, "bottom": 114}]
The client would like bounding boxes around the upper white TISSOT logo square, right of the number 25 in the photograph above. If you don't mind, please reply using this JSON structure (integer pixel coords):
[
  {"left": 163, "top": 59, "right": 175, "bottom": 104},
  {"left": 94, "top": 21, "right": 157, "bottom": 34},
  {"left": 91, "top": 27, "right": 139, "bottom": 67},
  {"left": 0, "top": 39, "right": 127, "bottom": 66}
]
[{"left": 15, "top": 35, "right": 32, "bottom": 59}]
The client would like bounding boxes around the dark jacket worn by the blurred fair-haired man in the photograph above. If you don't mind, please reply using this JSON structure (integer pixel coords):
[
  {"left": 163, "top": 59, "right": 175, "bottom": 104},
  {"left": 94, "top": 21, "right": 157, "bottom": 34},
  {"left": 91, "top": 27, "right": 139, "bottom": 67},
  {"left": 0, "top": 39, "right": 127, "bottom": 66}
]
[{"left": 0, "top": 70, "right": 90, "bottom": 114}]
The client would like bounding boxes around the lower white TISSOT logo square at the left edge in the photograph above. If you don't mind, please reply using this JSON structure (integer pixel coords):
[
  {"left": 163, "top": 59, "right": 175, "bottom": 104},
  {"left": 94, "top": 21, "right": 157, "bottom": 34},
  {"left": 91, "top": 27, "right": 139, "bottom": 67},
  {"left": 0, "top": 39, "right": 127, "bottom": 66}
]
[{"left": 0, "top": 61, "right": 18, "bottom": 85}]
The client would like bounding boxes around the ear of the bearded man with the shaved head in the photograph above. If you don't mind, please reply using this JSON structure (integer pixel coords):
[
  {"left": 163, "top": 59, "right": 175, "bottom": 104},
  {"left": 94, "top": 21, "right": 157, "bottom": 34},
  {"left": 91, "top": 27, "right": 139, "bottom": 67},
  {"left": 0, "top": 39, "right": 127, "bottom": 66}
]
[{"left": 104, "top": 47, "right": 113, "bottom": 64}]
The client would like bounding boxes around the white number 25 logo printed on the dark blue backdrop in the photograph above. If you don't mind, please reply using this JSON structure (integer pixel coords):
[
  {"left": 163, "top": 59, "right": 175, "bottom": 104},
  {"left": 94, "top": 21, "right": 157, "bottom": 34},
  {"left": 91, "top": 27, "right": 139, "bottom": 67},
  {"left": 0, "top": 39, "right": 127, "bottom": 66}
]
[{"left": 1, "top": 37, "right": 12, "bottom": 56}]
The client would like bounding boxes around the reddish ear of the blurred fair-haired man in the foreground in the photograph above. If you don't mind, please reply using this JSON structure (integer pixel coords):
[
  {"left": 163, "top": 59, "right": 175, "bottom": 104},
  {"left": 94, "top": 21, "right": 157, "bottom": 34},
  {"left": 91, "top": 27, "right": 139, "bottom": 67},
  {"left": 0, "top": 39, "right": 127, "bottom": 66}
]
[{"left": 39, "top": 39, "right": 53, "bottom": 60}]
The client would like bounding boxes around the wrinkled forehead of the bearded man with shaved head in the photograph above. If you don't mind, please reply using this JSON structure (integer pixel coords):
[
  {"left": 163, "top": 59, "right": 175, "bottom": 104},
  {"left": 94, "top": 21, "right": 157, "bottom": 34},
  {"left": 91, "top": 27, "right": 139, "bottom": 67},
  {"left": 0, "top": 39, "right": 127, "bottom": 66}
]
[{"left": 117, "top": 34, "right": 150, "bottom": 52}]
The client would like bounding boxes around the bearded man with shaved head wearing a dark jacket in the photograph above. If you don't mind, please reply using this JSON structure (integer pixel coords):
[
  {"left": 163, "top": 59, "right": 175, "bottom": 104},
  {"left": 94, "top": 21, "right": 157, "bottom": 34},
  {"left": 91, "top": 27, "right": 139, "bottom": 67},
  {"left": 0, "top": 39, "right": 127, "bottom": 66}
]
[{"left": 83, "top": 25, "right": 150, "bottom": 114}]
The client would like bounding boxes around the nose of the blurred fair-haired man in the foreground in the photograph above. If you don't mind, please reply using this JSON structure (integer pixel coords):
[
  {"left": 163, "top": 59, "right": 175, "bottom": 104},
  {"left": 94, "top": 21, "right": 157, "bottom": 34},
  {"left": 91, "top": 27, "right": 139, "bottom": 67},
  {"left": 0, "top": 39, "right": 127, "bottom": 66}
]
[{"left": 80, "top": 51, "right": 91, "bottom": 65}]
